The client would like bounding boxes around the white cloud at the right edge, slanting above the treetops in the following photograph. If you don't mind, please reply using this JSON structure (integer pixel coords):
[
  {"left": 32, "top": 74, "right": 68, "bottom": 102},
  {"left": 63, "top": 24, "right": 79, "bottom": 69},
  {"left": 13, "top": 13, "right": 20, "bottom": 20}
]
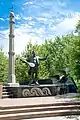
[{"left": 50, "top": 13, "right": 80, "bottom": 35}]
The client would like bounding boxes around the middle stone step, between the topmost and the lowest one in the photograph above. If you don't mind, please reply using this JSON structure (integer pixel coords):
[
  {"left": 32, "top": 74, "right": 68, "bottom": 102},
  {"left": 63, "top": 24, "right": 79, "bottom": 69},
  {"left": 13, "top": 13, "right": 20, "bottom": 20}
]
[{"left": 0, "top": 105, "right": 80, "bottom": 115}]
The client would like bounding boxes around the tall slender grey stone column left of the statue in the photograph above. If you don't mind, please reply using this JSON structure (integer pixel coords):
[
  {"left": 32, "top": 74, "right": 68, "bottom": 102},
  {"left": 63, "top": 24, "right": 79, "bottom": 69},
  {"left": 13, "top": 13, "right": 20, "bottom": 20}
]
[{"left": 8, "top": 12, "right": 16, "bottom": 83}]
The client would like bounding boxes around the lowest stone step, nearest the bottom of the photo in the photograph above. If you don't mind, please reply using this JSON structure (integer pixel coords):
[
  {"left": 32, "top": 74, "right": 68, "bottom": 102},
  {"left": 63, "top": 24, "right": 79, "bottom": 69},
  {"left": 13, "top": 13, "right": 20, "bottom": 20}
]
[{"left": 0, "top": 110, "right": 80, "bottom": 120}]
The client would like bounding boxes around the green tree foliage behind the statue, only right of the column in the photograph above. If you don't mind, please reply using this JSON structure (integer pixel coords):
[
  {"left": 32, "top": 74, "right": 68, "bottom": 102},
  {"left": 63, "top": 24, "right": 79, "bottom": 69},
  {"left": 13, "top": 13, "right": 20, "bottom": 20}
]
[{"left": 16, "top": 34, "right": 80, "bottom": 80}]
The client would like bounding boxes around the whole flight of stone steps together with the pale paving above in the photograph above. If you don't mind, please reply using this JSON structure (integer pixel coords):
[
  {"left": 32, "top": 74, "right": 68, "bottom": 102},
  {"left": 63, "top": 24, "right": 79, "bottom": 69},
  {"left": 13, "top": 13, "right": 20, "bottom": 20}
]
[{"left": 0, "top": 97, "right": 80, "bottom": 120}]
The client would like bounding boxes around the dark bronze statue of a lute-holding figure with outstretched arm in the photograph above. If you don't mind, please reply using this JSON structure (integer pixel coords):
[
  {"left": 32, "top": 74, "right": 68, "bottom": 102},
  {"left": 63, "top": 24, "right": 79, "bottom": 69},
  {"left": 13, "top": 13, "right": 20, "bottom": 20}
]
[{"left": 16, "top": 51, "right": 47, "bottom": 85}]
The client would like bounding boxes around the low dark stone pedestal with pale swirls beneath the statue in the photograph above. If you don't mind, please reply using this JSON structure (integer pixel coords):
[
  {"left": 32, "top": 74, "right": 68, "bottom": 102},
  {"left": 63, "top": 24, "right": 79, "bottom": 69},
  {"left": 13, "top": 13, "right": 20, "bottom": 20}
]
[{"left": 7, "top": 84, "right": 67, "bottom": 98}]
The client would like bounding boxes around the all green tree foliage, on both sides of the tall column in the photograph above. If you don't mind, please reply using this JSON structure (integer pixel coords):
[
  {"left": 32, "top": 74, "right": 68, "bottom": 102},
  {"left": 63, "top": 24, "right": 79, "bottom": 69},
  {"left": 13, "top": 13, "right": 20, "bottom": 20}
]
[{"left": 0, "top": 21, "right": 80, "bottom": 81}]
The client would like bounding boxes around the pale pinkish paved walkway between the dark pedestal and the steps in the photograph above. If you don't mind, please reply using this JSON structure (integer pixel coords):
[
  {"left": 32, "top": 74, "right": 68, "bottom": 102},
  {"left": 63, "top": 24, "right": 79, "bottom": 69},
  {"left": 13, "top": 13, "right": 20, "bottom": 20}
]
[{"left": 0, "top": 94, "right": 80, "bottom": 107}]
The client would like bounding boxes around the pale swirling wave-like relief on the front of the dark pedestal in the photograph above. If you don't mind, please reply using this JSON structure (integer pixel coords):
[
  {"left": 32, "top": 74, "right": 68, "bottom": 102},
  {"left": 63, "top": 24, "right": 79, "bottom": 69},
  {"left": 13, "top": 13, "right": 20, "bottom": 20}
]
[{"left": 22, "top": 87, "right": 52, "bottom": 97}]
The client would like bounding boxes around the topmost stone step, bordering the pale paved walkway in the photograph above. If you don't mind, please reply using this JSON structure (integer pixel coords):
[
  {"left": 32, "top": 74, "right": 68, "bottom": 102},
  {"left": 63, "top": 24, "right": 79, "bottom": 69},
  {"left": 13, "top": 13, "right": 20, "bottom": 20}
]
[{"left": 0, "top": 100, "right": 80, "bottom": 110}]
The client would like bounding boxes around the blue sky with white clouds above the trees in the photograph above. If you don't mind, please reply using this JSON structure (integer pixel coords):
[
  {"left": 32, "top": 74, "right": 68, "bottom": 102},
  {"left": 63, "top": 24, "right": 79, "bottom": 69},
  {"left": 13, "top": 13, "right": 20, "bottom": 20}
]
[{"left": 0, "top": 0, "right": 80, "bottom": 54}]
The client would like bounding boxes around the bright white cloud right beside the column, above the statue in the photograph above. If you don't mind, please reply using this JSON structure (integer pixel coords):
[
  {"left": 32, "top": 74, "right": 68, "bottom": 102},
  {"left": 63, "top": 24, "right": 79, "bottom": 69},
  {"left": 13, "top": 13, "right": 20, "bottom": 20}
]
[{"left": 15, "top": 25, "right": 41, "bottom": 54}]
